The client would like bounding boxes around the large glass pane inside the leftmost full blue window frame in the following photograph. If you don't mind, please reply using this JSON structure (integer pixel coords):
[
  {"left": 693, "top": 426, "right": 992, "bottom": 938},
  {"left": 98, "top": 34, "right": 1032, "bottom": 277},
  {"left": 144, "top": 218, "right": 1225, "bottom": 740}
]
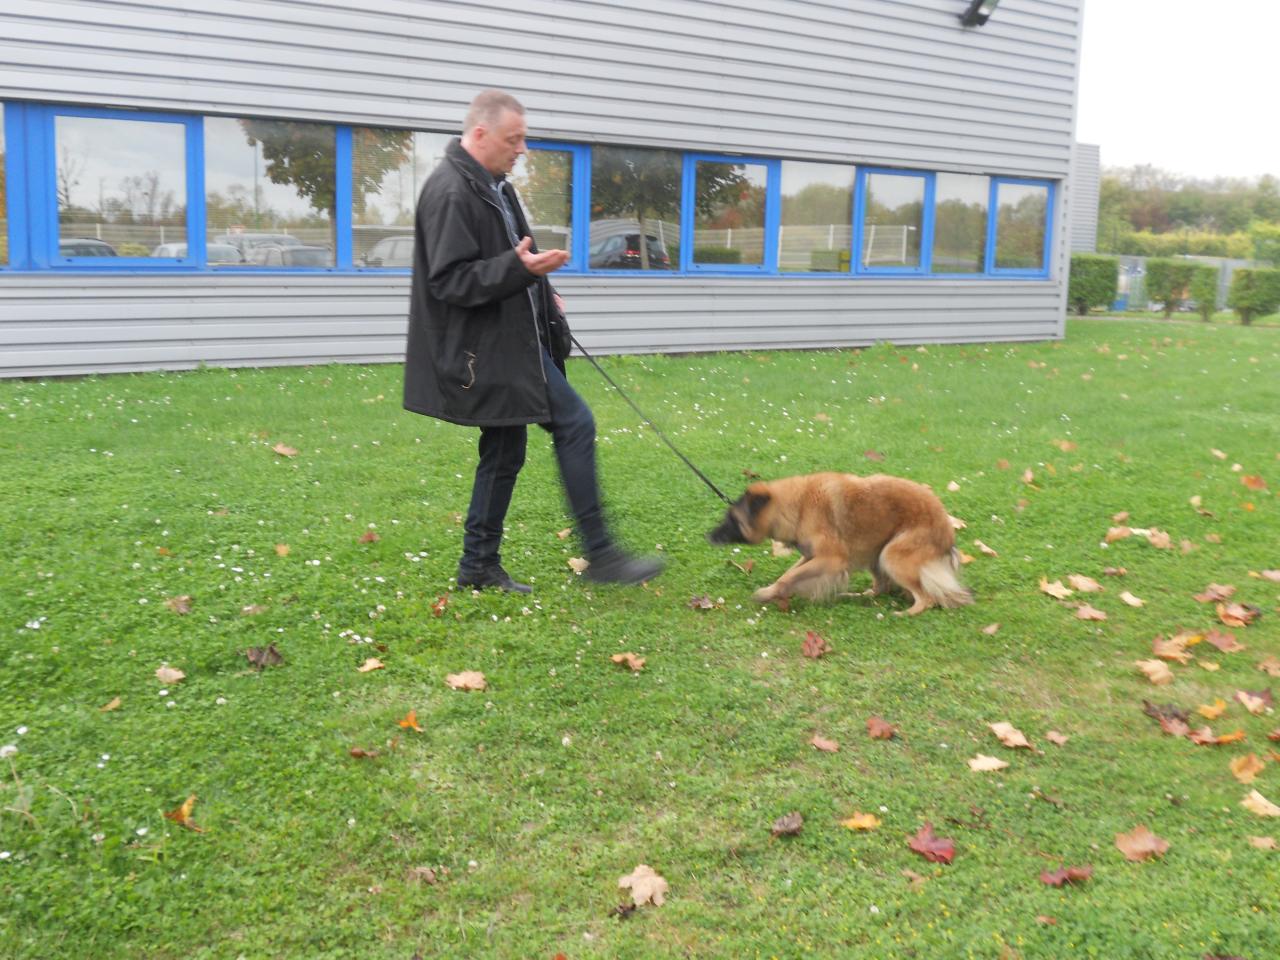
[{"left": 54, "top": 116, "right": 187, "bottom": 257}]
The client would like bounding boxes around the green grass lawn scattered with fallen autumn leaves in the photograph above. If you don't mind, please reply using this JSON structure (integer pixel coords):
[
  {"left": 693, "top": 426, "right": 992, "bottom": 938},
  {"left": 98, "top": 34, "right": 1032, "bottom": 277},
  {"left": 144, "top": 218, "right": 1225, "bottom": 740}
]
[{"left": 0, "top": 319, "right": 1280, "bottom": 960}]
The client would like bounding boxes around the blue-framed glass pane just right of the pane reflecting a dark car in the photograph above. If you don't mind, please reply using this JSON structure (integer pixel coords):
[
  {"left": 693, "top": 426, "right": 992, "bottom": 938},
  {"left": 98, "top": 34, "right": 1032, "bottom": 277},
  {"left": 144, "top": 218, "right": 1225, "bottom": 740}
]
[{"left": 689, "top": 157, "right": 769, "bottom": 269}]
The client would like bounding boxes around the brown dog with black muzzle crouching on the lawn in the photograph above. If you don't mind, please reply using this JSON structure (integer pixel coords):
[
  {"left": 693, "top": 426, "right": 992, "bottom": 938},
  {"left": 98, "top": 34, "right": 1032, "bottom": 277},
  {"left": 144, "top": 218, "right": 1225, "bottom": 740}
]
[{"left": 707, "top": 474, "right": 973, "bottom": 614}]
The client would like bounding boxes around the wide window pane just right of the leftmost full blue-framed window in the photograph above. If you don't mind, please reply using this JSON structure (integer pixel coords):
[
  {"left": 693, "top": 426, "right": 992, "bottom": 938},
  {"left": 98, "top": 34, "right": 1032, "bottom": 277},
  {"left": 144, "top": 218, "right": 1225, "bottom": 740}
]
[{"left": 205, "top": 116, "right": 337, "bottom": 269}]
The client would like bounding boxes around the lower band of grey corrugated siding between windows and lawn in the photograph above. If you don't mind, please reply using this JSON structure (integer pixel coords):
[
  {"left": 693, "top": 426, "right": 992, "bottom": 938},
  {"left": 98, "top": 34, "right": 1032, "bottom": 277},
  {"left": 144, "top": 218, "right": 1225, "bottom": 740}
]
[{"left": 0, "top": 274, "right": 1061, "bottom": 376}]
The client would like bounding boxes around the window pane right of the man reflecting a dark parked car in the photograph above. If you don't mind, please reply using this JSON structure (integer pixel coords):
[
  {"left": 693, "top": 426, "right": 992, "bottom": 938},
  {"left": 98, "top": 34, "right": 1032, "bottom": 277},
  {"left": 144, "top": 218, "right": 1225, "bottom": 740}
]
[{"left": 588, "top": 147, "right": 684, "bottom": 270}]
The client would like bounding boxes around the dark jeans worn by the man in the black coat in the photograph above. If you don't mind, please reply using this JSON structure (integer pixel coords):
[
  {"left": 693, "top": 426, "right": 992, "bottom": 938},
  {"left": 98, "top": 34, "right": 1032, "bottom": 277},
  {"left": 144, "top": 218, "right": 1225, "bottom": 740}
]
[{"left": 458, "top": 355, "right": 609, "bottom": 573}]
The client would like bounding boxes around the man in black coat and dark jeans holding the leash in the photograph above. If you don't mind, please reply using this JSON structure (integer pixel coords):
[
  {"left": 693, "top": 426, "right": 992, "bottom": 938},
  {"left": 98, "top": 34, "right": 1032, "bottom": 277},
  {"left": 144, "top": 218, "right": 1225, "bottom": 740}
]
[{"left": 404, "top": 90, "right": 662, "bottom": 593}]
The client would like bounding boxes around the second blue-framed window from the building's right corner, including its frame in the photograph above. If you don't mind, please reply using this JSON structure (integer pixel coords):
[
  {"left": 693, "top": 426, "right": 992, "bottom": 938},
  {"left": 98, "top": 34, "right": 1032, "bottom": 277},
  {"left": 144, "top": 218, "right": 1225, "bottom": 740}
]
[{"left": 854, "top": 166, "right": 933, "bottom": 276}]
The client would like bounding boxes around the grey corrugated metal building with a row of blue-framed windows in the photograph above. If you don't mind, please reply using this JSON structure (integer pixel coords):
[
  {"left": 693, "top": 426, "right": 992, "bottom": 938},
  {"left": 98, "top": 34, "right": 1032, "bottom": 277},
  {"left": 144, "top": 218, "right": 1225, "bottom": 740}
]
[{"left": 0, "top": 0, "right": 1083, "bottom": 376}]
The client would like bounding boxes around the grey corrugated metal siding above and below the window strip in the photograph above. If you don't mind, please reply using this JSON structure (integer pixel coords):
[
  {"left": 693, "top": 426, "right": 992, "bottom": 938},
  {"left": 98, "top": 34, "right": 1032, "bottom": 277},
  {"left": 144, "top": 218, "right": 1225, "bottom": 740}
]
[{"left": 0, "top": 0, "right": 1083, "bottom": 375}]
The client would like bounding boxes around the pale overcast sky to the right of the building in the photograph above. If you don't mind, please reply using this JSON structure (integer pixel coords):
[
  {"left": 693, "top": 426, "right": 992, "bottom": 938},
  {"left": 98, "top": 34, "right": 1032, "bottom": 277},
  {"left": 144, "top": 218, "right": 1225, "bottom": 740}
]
[{"left": 1080, "top": 0, "right": 1280, "bottom": 177}]
